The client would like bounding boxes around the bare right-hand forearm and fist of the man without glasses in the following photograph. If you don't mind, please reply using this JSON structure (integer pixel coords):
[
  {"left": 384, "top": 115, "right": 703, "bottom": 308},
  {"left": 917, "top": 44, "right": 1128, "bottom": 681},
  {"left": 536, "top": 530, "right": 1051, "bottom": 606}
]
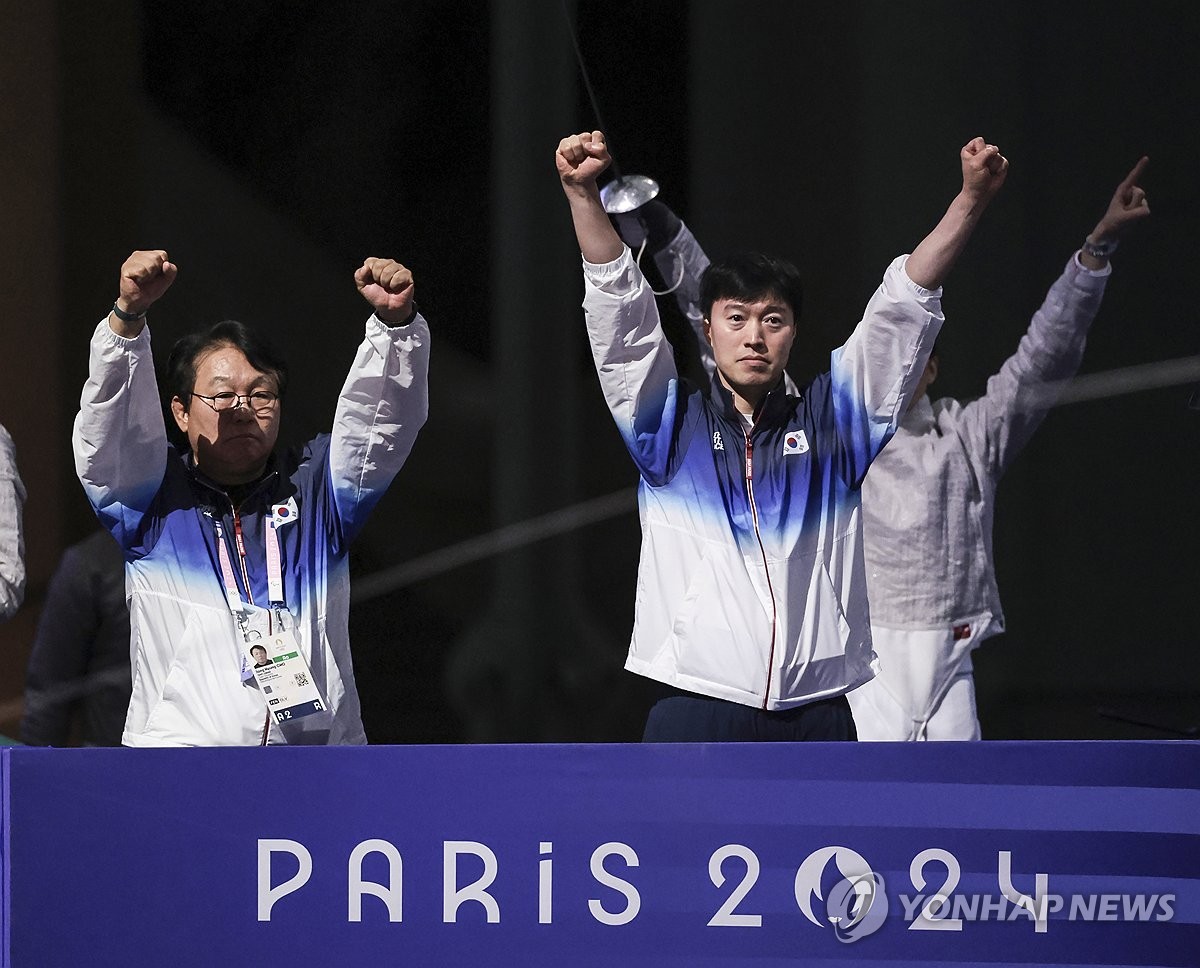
[{"left": 905, "top": 138, "right": 1008, "bottom": 289}]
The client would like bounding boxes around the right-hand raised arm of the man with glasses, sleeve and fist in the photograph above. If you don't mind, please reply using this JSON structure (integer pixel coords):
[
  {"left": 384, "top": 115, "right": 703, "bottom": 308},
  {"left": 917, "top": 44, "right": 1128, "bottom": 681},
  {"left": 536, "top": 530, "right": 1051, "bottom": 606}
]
[{"left": 330, "top": 258, "right": 430, "bottom": 539}]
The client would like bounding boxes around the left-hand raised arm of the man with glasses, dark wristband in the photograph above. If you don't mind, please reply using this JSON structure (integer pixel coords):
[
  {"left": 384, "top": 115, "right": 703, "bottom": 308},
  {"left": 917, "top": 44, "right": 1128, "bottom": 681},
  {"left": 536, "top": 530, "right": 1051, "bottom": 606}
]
[{"left": 73, "top": 249, "right": 178, "bottom": 547}]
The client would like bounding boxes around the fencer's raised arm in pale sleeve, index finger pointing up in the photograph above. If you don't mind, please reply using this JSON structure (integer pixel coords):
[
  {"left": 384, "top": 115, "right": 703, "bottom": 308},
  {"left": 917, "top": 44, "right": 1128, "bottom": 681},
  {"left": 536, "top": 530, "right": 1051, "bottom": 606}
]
[{"left": 961, "top": 157, "right": 1150, "bottom": 479}]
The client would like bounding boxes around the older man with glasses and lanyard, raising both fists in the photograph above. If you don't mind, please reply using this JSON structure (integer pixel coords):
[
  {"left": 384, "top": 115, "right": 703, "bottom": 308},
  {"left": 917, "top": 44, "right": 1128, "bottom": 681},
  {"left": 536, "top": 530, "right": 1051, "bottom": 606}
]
[{"left": 74, "top": 251, "right": 430, "bottom": 746}]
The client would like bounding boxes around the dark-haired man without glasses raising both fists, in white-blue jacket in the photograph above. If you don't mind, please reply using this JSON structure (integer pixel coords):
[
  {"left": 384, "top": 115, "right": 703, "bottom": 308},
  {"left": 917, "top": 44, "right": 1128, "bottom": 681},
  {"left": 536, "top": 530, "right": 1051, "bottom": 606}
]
[{"left": 556, "top": 131, "right": 1008, "bottom": 741}]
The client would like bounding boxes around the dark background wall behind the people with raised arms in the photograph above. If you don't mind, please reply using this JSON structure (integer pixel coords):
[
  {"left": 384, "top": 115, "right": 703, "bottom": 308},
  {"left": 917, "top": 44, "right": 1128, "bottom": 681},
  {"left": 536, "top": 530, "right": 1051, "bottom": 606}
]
[{"left": 0, "top": 0, "right": 1200, "bottom": 742}]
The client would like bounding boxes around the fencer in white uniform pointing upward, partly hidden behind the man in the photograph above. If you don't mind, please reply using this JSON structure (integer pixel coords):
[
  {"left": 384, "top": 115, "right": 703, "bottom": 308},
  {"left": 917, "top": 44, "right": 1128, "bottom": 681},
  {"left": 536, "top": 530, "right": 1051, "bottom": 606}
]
[{"left": 614, "top": 158, "right": 1150, "bottom": 740}]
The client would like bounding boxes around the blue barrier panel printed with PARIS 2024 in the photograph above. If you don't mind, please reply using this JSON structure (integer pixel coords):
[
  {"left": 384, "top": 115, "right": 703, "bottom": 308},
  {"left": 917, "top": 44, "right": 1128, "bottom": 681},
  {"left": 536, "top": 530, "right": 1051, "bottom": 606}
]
[{"left": 0, "top": 742, "right": 1200, "bottom": 968}]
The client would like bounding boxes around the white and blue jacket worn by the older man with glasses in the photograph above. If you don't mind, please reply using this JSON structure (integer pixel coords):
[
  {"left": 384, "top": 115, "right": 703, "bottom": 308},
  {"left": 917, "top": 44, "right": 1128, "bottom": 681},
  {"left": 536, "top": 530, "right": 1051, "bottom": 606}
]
[{"left": 73, "top": 315, "right": 430, "bottom": 746}]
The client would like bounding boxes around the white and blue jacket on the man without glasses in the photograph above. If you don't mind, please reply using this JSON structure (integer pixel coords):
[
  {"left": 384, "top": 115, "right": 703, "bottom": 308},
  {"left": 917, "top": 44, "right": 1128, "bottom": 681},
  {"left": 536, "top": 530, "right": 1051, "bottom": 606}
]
[{"left": 583, "top": 248, "right": 942, "bottom": 709}]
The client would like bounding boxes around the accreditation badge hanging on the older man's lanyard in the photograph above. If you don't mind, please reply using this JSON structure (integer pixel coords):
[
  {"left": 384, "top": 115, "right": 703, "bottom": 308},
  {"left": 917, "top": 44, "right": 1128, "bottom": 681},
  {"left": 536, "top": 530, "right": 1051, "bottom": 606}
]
[{"left": 242, "top": 606, "right": 328, "bottom": 723}]
